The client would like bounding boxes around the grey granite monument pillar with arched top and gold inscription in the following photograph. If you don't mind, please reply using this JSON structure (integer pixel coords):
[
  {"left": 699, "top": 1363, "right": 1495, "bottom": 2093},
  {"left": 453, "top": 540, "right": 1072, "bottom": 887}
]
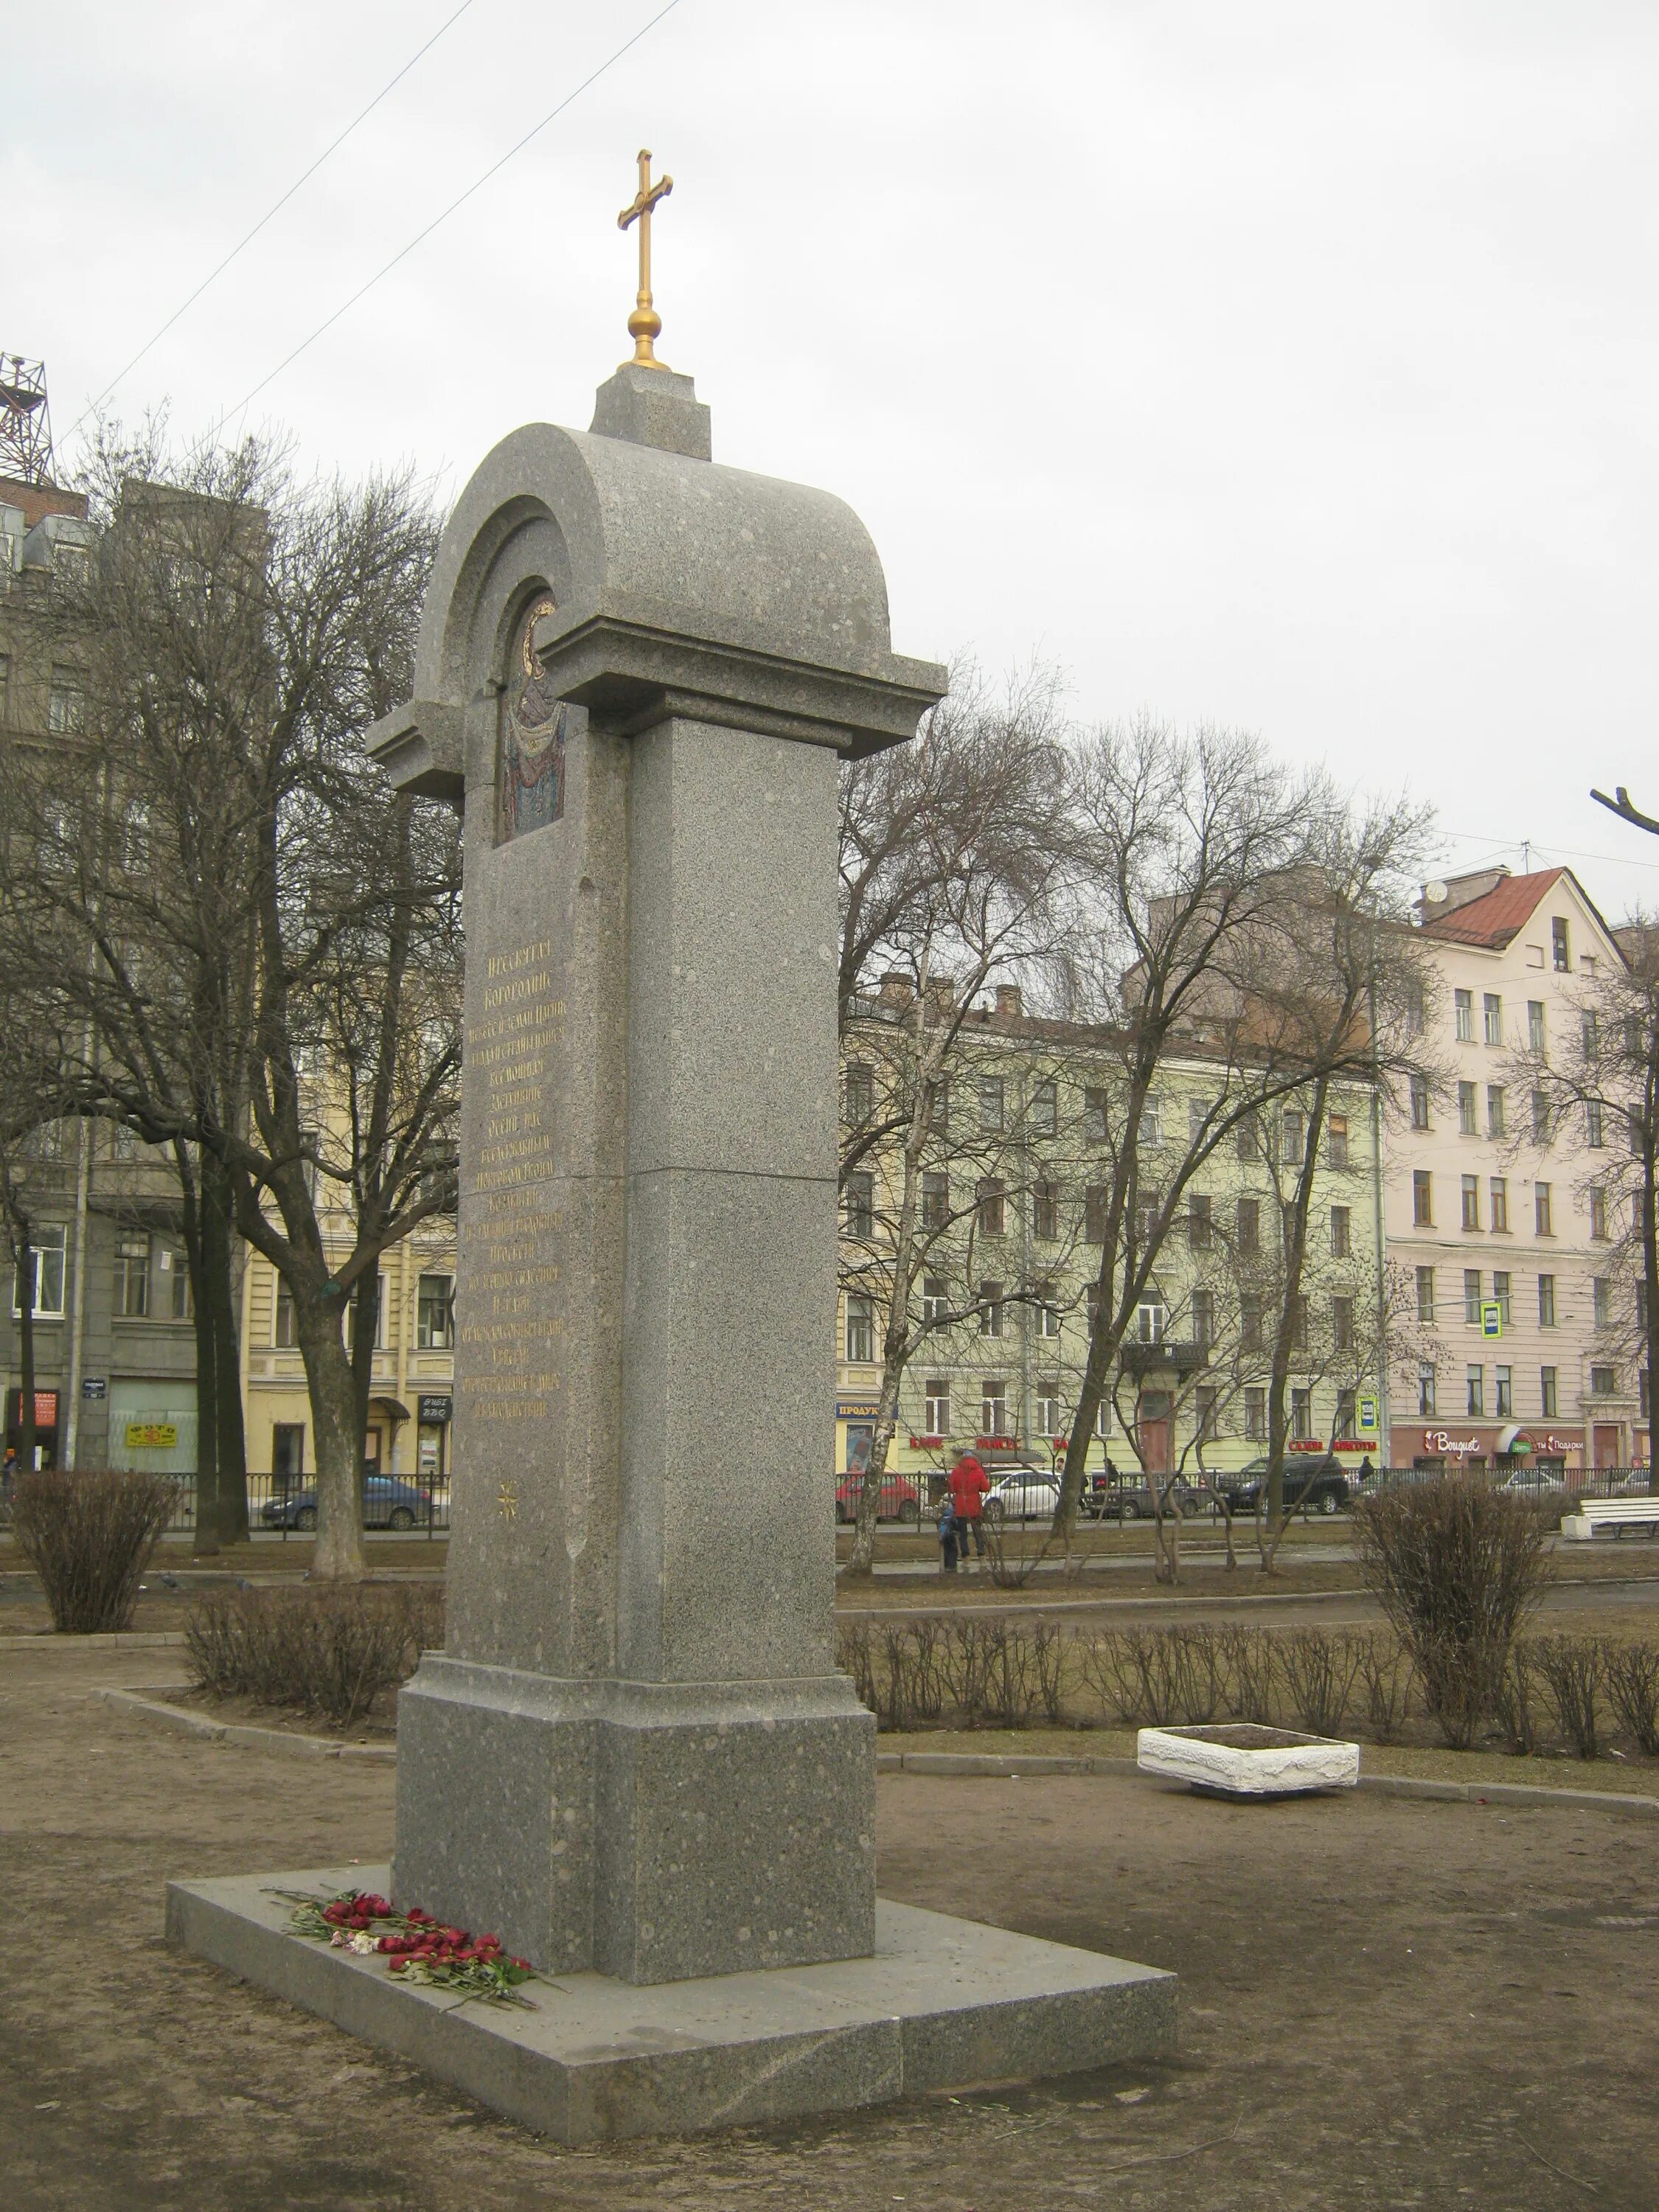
[{"left": 372, "top": 367, "right": 945, "bottom": 1982}]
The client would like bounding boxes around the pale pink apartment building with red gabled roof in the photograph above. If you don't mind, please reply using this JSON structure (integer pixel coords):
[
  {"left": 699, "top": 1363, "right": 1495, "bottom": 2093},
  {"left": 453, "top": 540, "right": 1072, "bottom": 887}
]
[{"left": 1385, "top": 867, "right": 1646, "bottom": 1467}]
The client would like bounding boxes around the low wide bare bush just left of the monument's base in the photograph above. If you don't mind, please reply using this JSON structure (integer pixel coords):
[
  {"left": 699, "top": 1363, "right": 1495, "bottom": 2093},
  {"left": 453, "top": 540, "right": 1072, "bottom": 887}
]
[{"left": 184, "top": 1584, "right": 442, "bottom": 1728}]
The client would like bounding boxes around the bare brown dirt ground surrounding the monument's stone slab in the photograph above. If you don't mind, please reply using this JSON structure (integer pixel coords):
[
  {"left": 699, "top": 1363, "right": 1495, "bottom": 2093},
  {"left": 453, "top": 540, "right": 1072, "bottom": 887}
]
[{"left": 0, "top": 1644, "right": 1659, "bottom": 2212}]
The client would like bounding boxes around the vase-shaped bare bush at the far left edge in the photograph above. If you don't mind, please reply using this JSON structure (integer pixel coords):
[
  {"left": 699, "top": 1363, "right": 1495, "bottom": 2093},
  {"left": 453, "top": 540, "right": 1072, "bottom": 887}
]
[{"left": 11, "top": 1469, "right": 179, "bottom": 1637}]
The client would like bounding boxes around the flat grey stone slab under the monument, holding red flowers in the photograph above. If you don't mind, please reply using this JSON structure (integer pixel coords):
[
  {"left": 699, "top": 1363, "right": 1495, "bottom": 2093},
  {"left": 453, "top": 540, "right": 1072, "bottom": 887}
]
[{"left": 168, "top": 1867, "right": 1177, "bottom": 2143}]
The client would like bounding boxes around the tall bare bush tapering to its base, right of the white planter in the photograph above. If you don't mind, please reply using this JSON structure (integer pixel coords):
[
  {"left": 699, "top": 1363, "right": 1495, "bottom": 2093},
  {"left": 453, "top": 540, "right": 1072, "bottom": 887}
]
[{"left": 1354, "top": 1475, "right": 1551, "bottom": 1750}]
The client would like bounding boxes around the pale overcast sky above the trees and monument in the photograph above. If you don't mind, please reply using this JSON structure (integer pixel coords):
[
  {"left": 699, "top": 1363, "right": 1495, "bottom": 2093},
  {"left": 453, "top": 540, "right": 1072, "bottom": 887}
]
[{"left": 13, "top": 0, "right": 1659, "bottom": 916}]
